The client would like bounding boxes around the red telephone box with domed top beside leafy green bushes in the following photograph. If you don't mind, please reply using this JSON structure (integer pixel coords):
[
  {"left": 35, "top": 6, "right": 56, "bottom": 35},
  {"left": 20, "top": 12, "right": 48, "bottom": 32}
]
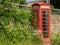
[{"left": 32, "top": 2, "right": 50, "bottom": 43}]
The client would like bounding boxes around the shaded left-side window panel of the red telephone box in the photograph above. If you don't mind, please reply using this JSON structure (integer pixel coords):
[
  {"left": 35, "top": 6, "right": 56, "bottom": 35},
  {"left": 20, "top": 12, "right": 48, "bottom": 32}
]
[{"left": 32, "top": 4, "right": 40, "bottom": 29}]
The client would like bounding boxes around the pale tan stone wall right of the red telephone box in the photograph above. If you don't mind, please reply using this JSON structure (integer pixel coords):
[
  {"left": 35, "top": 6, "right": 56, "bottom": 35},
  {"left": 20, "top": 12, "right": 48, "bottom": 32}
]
[{"left": 51, "top": 14, "right": 60, "bottom": 33}]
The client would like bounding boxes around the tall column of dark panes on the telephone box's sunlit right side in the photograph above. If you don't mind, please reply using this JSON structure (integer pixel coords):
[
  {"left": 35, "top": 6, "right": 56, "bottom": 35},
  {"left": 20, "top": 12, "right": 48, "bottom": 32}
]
[{"left": 42, "top": 11, "right": 48, "bottom": 38}]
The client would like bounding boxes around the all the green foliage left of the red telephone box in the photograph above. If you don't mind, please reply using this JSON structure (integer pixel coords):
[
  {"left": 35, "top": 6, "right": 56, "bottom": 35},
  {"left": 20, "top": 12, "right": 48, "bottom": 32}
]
[{"left": 0, "top": 0, "right": 41, "bottom": 45}]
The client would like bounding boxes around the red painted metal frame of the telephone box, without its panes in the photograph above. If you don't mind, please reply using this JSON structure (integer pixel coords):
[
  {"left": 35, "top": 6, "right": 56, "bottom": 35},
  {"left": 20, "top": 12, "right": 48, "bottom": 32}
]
[{"left": 32, "top": 2, "right": 50, "bottom": 43}]
